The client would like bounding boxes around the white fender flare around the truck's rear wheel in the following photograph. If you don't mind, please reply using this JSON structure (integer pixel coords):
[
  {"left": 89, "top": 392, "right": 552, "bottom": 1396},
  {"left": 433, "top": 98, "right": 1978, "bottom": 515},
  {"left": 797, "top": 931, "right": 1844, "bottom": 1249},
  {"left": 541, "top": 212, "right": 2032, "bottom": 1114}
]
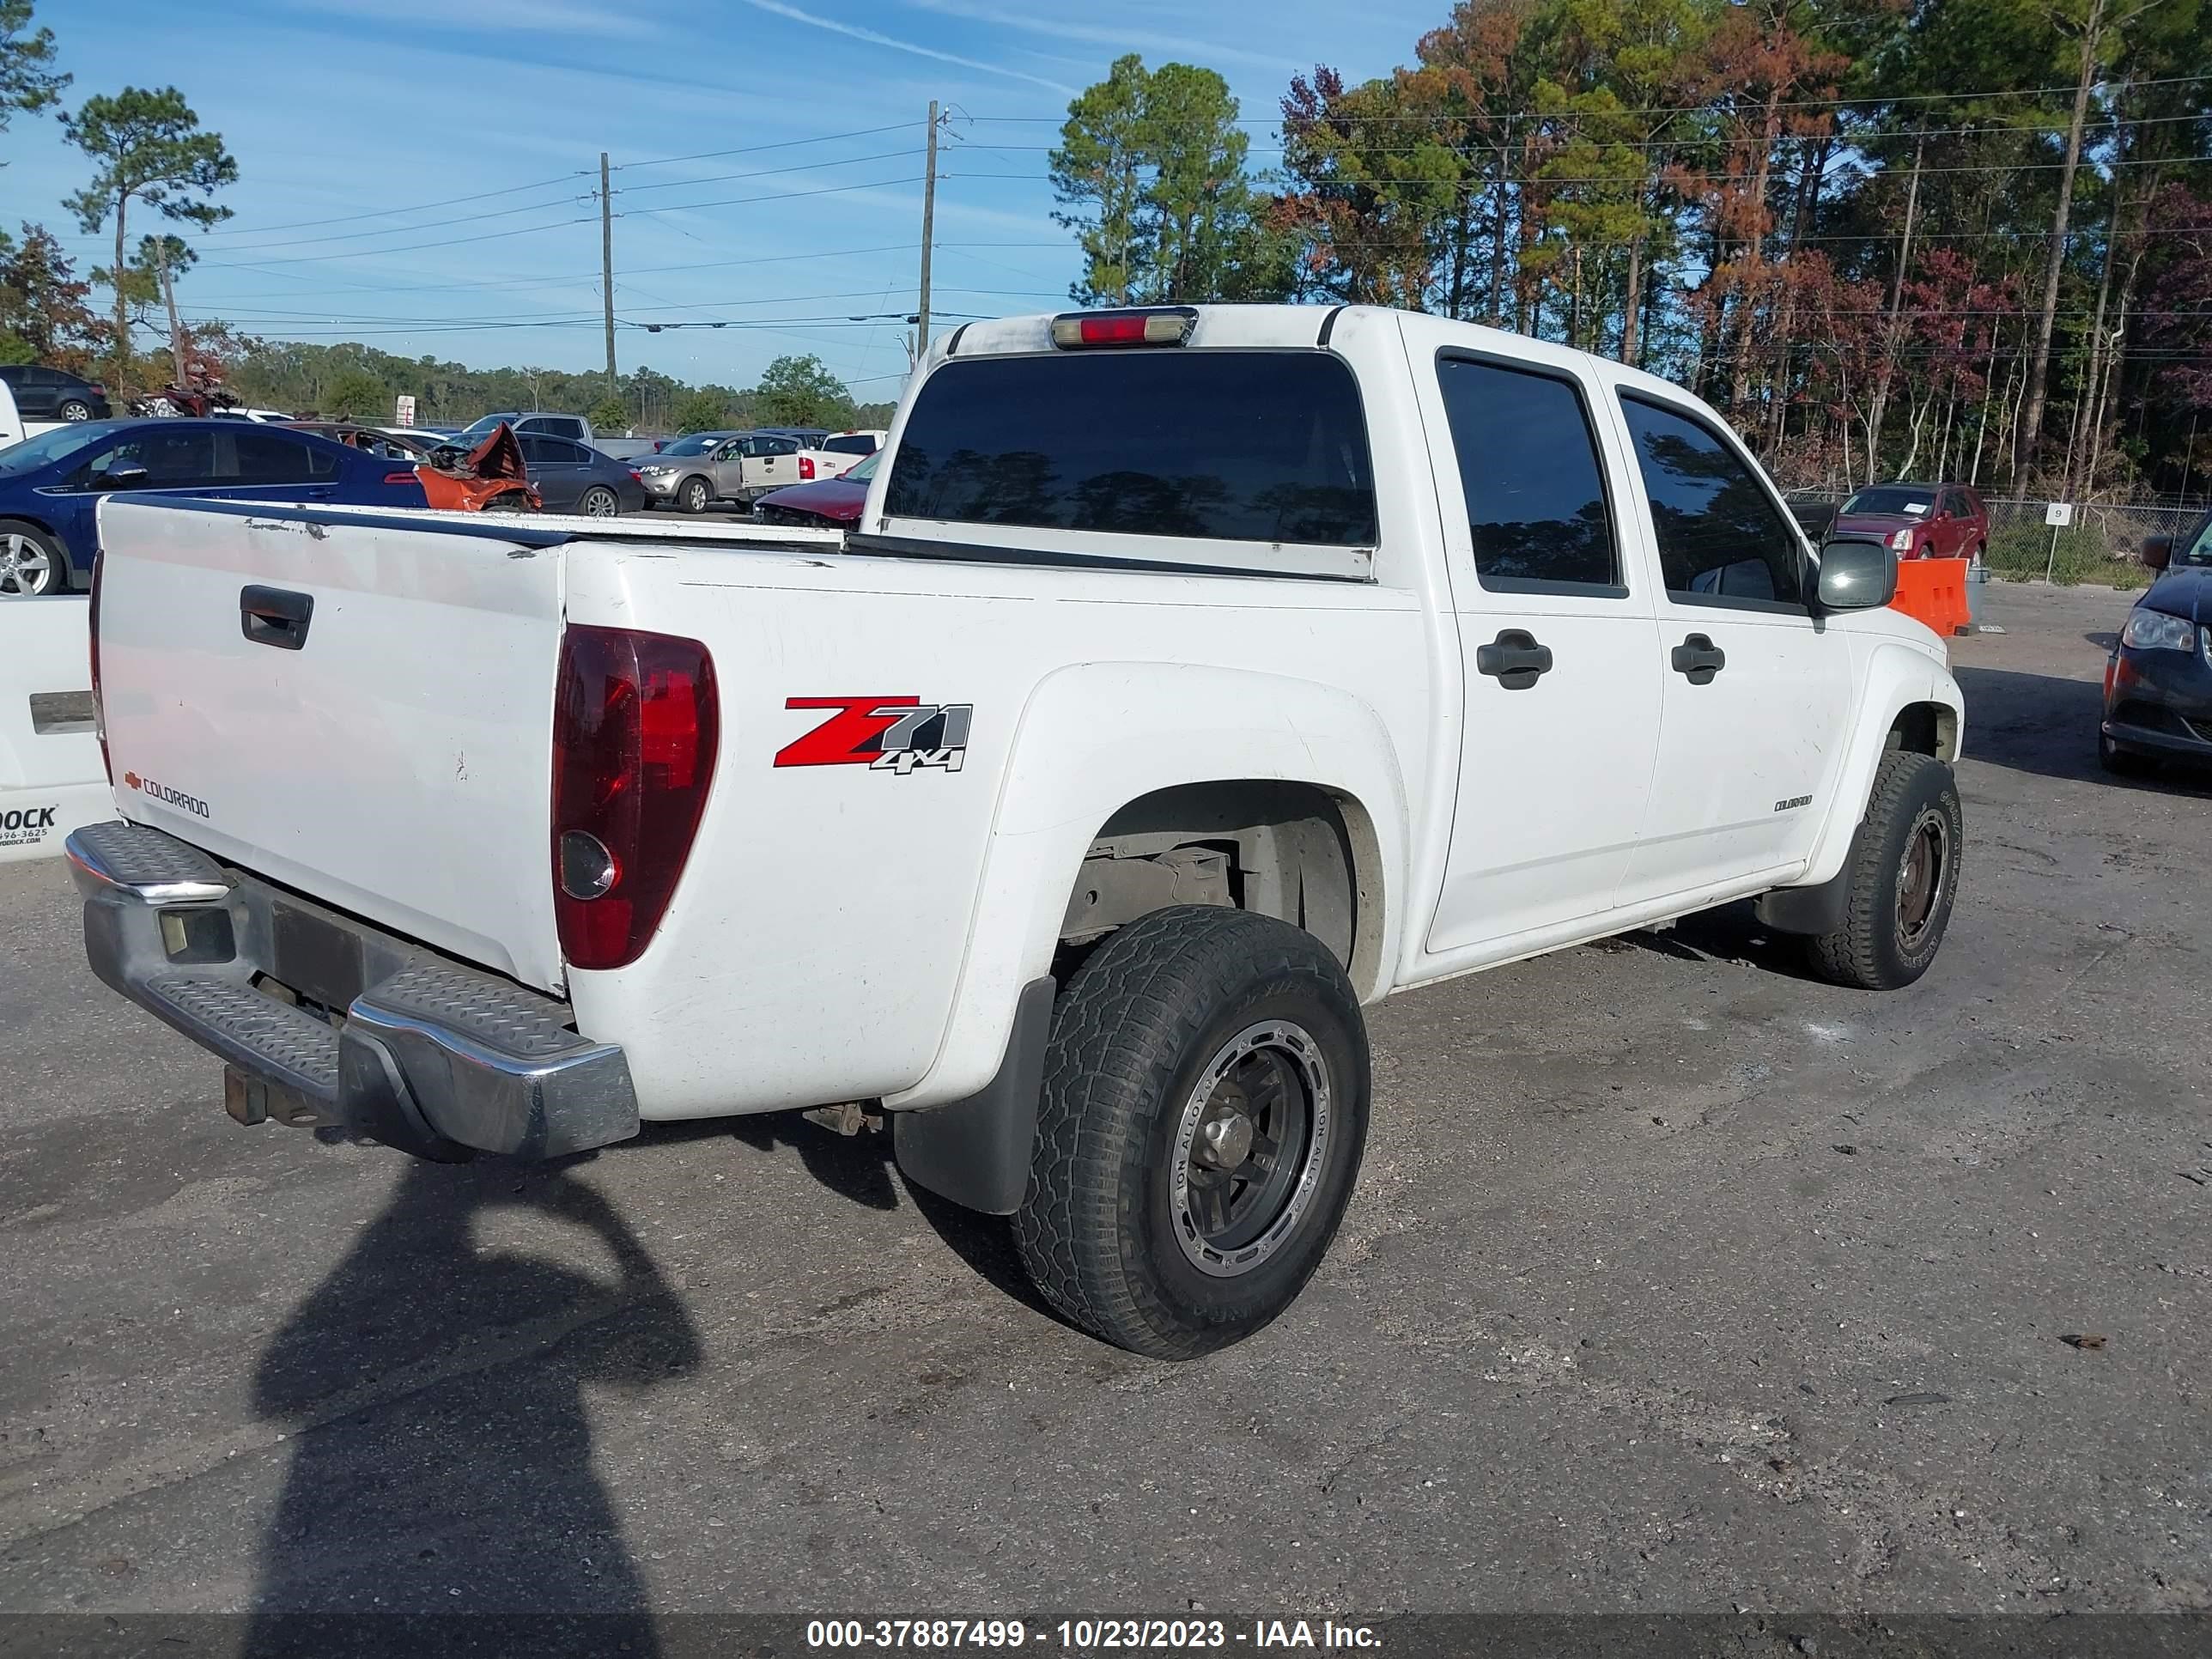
[{"left": 884, "top": 661, "right": 1409, "bottom": 1110}]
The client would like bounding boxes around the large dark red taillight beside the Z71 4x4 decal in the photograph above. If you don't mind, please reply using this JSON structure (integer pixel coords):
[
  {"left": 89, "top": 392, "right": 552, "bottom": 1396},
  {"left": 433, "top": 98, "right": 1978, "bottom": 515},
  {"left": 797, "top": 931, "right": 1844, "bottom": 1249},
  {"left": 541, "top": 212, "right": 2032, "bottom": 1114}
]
[{"left": 553, "top": 629, "right": 719, "bottom": 969}]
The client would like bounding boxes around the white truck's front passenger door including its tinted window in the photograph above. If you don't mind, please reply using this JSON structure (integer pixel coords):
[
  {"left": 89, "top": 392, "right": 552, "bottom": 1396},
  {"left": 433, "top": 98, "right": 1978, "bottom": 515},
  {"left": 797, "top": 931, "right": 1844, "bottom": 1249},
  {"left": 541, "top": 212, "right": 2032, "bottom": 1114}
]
[{"left": 1614, "top": 389, "right": 1851, "bottom": 902}]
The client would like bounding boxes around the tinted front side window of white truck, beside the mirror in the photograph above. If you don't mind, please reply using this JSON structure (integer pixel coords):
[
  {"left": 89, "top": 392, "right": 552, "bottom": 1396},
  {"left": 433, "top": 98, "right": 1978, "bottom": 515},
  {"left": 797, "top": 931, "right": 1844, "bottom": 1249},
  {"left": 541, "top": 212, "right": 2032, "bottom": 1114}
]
[{"left": 1621, "top": 396, "right": 1805, "bottom": 608}]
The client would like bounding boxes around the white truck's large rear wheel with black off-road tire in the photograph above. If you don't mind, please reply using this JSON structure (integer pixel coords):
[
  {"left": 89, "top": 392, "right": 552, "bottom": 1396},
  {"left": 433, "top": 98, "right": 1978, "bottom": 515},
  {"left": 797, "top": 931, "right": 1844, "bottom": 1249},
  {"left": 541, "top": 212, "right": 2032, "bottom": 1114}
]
[{"left": 1013, "top": 905, "right": 1370, "bottom": 1360}]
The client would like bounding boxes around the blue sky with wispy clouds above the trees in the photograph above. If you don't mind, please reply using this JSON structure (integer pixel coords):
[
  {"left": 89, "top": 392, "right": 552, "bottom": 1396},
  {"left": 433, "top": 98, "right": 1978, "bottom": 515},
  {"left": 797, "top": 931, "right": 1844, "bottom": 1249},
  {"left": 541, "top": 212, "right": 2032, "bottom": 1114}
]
[{"left": 0, "top": 0, "right": 1449, "bottom": 398}]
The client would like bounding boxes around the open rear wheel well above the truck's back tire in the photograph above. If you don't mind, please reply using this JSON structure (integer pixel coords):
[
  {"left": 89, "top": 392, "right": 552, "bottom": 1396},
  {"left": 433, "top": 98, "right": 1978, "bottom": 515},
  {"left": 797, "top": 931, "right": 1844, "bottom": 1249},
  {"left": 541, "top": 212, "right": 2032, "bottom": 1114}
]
[{"left": 1060, "top": 779, "right": 1382, "bottom": 984}]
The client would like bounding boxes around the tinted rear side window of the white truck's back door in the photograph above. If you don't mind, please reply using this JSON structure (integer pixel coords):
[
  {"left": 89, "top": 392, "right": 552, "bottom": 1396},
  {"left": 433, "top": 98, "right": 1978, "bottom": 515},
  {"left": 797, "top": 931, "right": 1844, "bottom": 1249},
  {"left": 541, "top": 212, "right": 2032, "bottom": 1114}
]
[{"left": 1436, "top": 356, "right": 1624, "bottom": 592}]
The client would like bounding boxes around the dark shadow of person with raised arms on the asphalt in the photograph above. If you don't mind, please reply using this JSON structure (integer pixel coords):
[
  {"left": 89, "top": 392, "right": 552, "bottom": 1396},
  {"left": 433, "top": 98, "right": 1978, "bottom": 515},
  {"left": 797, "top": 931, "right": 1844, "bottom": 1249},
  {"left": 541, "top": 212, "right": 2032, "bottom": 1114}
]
[{"left": 241, "top": 1161, "right": 702, "bottom": 1659}]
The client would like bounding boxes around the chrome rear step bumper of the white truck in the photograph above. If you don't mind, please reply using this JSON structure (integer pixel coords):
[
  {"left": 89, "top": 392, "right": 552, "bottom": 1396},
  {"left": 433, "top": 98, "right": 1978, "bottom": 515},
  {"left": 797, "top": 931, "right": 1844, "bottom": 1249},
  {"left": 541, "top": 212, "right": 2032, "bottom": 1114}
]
[{"left": 66, "top": 823, "right": 637, "bottom": 1161}]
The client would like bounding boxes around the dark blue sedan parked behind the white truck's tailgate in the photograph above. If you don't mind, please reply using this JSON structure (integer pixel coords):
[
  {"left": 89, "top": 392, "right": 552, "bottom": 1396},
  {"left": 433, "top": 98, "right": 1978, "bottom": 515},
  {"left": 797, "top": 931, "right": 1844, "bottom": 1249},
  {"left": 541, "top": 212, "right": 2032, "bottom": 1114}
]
[{"left": 0, "top": 418, "right": 427, "bottom": 599}]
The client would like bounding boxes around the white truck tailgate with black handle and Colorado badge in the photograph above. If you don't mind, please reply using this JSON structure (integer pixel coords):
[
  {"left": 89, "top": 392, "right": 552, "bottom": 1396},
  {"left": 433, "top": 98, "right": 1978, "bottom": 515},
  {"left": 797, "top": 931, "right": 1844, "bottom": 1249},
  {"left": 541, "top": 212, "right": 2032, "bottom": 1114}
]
[{"left": 95, "top": 498, "right": 562, "bottom": 991}]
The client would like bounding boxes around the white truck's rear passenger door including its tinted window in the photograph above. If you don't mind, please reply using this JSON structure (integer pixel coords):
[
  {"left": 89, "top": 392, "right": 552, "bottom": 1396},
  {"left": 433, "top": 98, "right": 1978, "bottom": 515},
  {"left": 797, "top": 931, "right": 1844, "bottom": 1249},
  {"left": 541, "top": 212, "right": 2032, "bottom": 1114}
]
[{"left": 1407, "top": 344, "right": 1659, "bottom": 953}]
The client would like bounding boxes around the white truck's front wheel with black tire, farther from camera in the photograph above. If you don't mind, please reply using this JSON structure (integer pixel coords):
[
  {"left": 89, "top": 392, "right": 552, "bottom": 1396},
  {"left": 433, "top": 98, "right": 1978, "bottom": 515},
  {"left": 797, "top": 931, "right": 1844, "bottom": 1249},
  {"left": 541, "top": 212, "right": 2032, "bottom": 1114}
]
[{"left": 1808, "top": 750, "right": 1966, "bottom": 991}]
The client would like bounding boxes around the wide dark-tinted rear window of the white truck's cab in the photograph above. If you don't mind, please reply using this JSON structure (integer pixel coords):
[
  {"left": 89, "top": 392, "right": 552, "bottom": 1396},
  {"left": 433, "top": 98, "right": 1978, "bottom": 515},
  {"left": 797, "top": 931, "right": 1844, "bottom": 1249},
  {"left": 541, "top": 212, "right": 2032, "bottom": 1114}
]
[{"left": 884, "top": 349, "right": 1376, "bottom": 546}]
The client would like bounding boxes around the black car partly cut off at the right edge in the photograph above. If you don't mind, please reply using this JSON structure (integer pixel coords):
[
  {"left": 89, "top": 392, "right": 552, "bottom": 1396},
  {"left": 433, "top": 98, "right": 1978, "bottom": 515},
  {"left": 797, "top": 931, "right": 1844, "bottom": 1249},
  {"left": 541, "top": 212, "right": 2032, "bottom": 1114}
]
[{"left": 2097, "top": 514, "right": 2212, "bottom": 772}]
